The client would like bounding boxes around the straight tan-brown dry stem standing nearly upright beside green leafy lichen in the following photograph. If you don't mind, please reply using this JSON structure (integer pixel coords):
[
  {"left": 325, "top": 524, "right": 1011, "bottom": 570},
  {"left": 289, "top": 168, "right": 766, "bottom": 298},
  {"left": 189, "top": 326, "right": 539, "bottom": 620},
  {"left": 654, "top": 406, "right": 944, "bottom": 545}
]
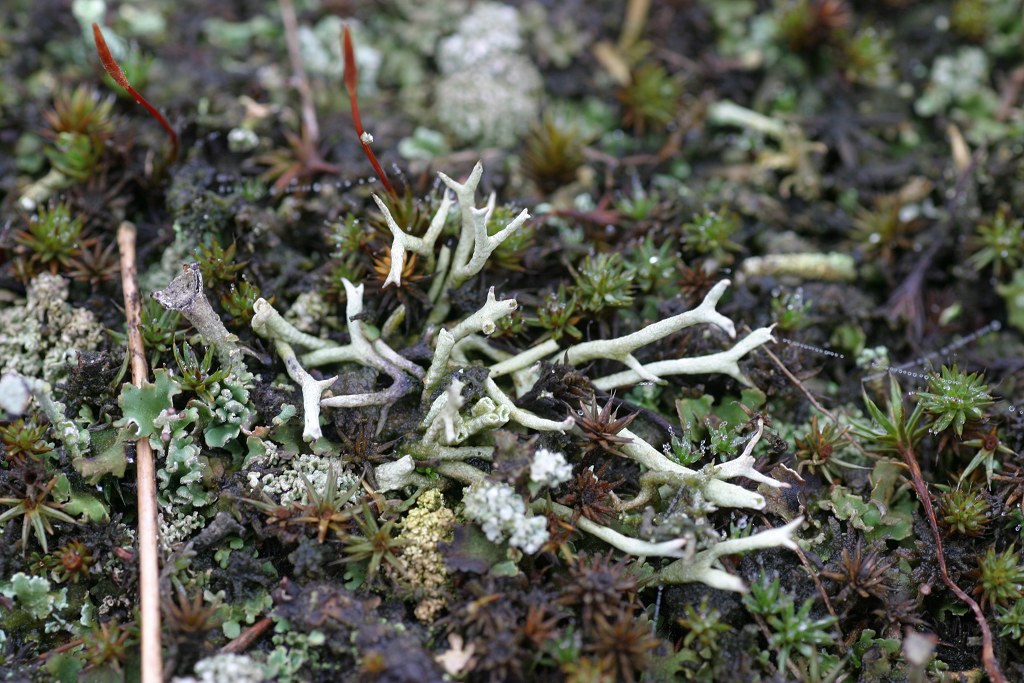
[{"left": 118, "top": 221, "right": 164, "bottom": 683}]
